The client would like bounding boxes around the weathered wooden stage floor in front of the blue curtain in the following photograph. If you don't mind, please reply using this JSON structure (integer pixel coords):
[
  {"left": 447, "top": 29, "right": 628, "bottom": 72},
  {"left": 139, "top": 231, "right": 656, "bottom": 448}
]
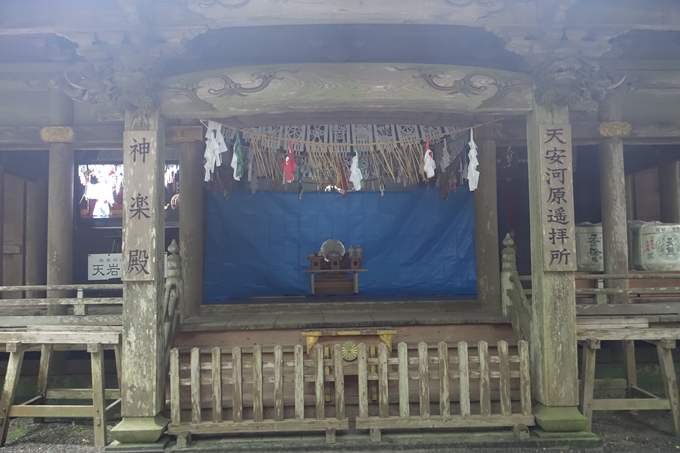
[{"left": 180, "top": 295, "right": 510, "bottom": 332}]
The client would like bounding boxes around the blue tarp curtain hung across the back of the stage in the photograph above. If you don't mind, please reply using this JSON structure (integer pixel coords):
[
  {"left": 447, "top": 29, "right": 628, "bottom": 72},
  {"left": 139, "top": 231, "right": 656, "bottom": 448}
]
[{"left": 203, "top": 188, "right": 477, "bottom": 303}]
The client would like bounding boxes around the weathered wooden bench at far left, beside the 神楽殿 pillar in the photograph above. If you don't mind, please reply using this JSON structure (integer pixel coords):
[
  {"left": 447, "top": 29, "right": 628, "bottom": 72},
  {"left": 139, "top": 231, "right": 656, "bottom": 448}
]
[{"left": 0, "top": 326, "right": 122, "bottom": 447}]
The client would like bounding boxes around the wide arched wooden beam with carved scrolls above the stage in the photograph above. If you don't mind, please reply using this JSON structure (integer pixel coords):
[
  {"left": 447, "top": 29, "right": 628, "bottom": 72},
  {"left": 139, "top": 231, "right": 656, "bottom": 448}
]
[{"left": 161, "top": 63, "right": 531, "bottom": 118}]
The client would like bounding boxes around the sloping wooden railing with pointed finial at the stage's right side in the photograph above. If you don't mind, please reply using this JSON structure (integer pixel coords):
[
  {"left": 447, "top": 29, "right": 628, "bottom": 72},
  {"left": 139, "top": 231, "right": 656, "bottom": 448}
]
[{"left": 501, "top": 234, "right": 532, "bottom": 341}]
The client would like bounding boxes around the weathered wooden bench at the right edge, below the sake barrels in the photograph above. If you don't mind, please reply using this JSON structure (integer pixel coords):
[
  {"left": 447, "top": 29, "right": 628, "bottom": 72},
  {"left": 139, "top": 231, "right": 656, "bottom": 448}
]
[{"left": 577, "top": 318, "right": 680, "bottom": 437}]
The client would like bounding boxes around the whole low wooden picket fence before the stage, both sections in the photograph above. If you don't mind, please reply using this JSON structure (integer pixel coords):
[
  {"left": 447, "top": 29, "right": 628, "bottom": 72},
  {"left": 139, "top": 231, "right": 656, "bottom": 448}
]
[{"left": 168, "top": 341, "right": 534, "bottom": 445}]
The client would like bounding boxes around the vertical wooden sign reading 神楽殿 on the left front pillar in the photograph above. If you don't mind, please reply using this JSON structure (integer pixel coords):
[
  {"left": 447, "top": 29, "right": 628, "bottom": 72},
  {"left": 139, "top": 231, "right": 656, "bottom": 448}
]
[{"left": 121, "top": 131, "right": 161, "bottom": 281}]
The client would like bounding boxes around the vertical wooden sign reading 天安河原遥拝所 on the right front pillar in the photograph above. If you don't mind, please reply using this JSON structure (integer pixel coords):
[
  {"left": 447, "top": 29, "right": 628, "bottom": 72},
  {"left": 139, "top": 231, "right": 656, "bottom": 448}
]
[{"left": 539, "top": 124, "right": 576, "bottom": 272}]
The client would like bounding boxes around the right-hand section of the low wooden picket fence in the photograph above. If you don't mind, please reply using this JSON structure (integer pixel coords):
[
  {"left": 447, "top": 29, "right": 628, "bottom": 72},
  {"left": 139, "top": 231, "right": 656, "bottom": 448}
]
[{"left": 356, "top": 341, "right": 534, "bottom": 441}]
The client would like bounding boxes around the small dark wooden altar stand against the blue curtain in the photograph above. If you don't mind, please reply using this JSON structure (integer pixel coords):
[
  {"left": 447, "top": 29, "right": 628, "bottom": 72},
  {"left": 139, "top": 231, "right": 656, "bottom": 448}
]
[{"left": 302, "top": 253, "right": 367, "bottom": 294}]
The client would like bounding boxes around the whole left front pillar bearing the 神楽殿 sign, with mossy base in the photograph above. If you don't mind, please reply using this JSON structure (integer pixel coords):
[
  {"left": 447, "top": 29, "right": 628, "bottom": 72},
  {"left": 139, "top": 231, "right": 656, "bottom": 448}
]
[{"left": 111, "top": 111, "right": 167, "bottom": 443}]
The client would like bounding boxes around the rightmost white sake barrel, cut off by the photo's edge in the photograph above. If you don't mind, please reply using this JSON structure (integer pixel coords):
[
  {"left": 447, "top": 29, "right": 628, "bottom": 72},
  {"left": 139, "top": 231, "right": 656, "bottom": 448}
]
[{"left": 631, "top": 222, "right": 680, "bottom": 271}]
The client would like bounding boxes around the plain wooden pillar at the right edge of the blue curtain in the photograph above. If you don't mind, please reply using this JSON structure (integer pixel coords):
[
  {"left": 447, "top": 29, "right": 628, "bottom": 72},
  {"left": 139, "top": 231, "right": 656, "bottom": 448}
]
[{"left": 475, "top": 140, "right": 501, "bottom": 311}]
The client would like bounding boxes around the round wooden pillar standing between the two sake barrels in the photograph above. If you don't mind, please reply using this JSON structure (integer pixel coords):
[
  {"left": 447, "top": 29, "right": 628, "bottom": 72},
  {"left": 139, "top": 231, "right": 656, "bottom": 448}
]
[{"left": 598, "top": 93, "right": 628, "bottom": 304}]
